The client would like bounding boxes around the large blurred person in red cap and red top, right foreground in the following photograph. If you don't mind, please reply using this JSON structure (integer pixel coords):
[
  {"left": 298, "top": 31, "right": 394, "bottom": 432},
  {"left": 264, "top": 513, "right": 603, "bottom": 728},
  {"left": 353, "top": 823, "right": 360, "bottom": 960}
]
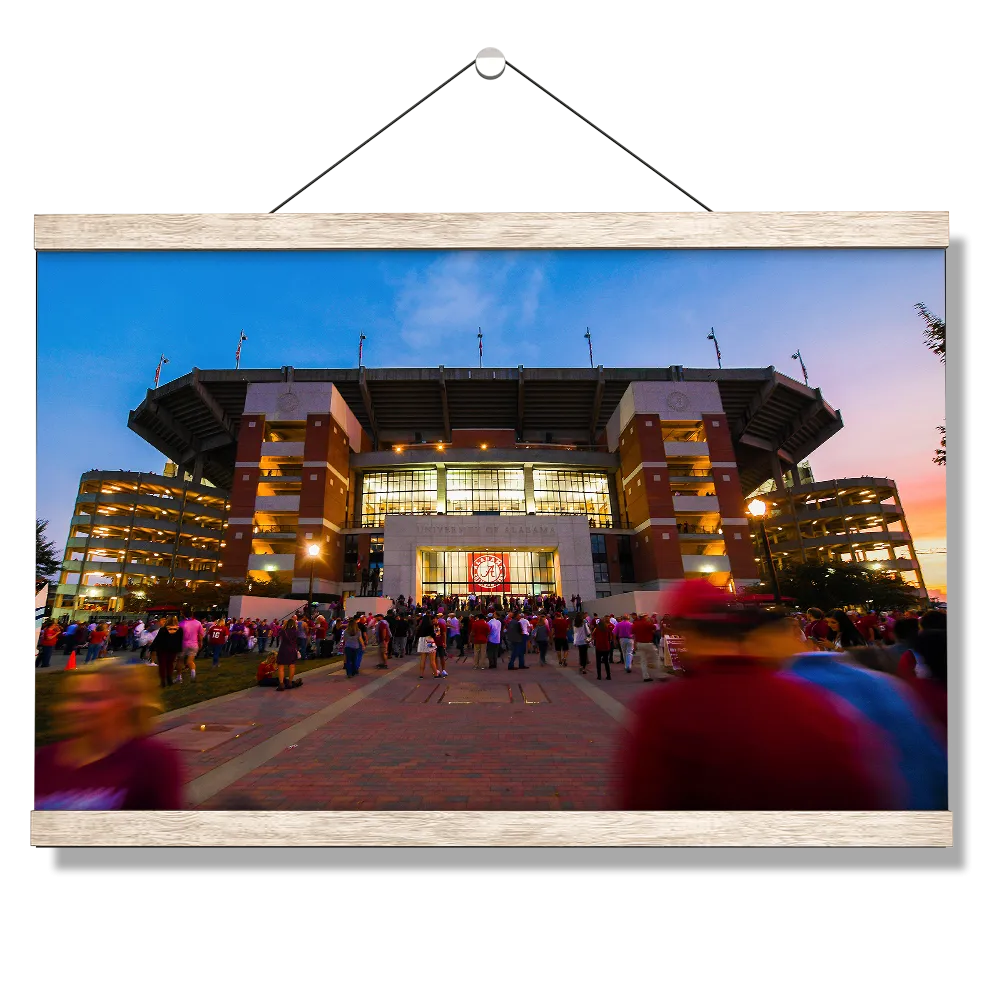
[{"left": 619, "top": 580, "right": 905, "bottom": 810}]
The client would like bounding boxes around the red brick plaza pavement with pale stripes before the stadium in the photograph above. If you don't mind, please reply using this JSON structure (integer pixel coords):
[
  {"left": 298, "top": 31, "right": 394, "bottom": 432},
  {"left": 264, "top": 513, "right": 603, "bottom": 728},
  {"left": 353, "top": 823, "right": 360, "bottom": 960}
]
[{"left": 148, "top": 650, "right": 676, "bottom": 810}]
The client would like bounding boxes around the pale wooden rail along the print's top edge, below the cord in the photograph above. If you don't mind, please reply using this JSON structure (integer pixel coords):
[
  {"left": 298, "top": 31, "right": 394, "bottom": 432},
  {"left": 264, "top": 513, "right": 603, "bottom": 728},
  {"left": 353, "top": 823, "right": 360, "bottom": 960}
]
[{"left": 32, "top": 208, "right": 951, "bottom": 251}]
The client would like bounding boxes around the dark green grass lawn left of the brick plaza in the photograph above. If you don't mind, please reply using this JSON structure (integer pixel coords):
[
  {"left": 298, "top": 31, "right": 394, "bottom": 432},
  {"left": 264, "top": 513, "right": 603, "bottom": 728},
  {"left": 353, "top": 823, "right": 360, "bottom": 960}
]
[{"left": 35, "top": 653, "right": 344, "bottom": 747}]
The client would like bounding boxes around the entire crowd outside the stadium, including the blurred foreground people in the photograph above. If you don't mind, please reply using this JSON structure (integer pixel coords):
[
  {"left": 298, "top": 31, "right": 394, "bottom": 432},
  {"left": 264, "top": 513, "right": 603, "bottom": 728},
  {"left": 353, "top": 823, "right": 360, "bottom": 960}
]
[{"left": 36, "top": 581, "right": 948, "bottom": 810}]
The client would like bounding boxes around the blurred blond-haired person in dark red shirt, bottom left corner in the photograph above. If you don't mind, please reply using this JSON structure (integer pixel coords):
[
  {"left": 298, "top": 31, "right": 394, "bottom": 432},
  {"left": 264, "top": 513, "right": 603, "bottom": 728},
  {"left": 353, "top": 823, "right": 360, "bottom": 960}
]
[{"left": 35, "top": 663, "right": 183, "bottom": 810}]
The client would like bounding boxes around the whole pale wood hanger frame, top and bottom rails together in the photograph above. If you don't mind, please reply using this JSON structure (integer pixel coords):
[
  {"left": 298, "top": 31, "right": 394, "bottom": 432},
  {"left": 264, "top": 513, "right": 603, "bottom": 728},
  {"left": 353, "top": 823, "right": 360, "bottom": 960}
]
[{"left": 31, "top": 209, "right": 954, "bottom": 847}]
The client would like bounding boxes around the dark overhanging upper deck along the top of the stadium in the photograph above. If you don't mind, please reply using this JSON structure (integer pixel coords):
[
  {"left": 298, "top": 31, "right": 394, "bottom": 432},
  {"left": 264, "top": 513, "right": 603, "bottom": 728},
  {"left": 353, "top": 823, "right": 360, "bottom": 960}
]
[{"left": 128, "top": 366, "right": 843, "bottom": 494}]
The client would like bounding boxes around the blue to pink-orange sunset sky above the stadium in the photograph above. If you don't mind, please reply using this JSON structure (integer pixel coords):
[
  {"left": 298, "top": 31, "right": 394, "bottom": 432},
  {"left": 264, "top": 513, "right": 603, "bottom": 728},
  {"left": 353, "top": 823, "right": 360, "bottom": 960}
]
[{"left": 35, "top": 250, "right": 947, "bottom": 597}]
